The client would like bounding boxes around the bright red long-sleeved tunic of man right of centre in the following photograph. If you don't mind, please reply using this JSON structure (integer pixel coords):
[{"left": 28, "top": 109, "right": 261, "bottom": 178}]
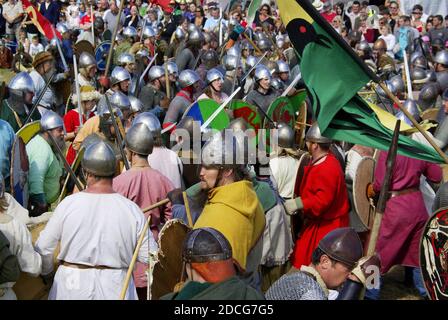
[{"left": 291, "top": 153, "right": 350, "bottom": 268}]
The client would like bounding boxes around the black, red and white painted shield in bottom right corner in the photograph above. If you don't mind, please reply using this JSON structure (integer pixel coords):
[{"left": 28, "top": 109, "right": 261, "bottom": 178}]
[{"left": 420, "top": 207, "right": 448, "bottom": 300}]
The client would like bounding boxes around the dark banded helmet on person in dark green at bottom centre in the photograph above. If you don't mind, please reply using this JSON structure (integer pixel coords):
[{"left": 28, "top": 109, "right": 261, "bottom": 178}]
[{"left": 182, "top": 227, "right": 232, "bottom": 262}]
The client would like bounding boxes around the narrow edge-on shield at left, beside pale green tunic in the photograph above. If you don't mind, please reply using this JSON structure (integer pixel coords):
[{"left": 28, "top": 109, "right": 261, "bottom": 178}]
[{"left": 11, "top": 136, "right": 30, "bottom": 208}]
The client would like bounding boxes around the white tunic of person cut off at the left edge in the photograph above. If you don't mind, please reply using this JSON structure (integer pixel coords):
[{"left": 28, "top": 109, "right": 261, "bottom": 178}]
[{"left": 0, "top": 193, "right": 42, "bottom": 300}]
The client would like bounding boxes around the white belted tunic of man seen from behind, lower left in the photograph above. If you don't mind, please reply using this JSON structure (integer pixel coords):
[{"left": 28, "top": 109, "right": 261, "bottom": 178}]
[{"left": 36, "top": 192, "right": 157, "bottom": 300}]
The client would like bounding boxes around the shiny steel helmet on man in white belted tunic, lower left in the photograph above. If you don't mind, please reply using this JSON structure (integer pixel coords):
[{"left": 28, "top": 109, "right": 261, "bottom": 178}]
[{"left": 81, "top": 141, "right": 117, "bottom": 177}]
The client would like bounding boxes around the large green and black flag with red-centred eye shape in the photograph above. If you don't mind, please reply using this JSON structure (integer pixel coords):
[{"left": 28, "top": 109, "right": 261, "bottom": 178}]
[{"left": 277, "top": 0, "right": 444, "bottom": 163}]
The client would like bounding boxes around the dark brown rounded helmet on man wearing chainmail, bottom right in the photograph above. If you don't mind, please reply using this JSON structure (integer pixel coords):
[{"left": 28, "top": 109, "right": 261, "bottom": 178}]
[{"left": 318, "top": 228, "right": 363, "bottom": 268}]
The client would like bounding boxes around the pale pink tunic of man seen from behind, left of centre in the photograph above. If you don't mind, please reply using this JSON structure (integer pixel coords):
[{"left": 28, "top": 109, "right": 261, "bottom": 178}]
[{"left": 113, "top": 168, "right": 174, "bottom": 288}]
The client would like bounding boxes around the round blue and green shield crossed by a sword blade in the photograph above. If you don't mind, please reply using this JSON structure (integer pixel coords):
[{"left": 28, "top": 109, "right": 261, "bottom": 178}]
[{"left": 182, "top": 99, "right": 230, "bottom": 130}]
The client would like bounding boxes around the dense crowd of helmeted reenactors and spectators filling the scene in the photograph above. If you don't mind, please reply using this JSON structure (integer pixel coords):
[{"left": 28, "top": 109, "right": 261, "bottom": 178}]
[{"left": 0, "top": 0, "right": 448, "bottom": 300}]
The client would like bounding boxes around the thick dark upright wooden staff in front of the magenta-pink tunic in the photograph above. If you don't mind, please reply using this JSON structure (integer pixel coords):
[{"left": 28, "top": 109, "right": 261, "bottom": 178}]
[{"left": 367, "top": 120, "right": 400, "bottom": 256}]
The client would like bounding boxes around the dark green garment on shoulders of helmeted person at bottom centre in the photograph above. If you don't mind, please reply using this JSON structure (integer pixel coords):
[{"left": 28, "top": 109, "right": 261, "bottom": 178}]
[{"left": 160, "top": 276, "right": 264, "bottom": 300}]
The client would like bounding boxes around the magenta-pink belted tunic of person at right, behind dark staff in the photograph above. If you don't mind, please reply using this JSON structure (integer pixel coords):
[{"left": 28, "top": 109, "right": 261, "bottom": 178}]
[{"left": 373, "top": 151, "right": 442, "bottom": 273}]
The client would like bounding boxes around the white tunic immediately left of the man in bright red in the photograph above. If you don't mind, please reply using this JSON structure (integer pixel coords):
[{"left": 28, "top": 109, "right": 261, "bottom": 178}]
[{"left": 269, "top": 156, "right": 299, "bottom": 199}]
